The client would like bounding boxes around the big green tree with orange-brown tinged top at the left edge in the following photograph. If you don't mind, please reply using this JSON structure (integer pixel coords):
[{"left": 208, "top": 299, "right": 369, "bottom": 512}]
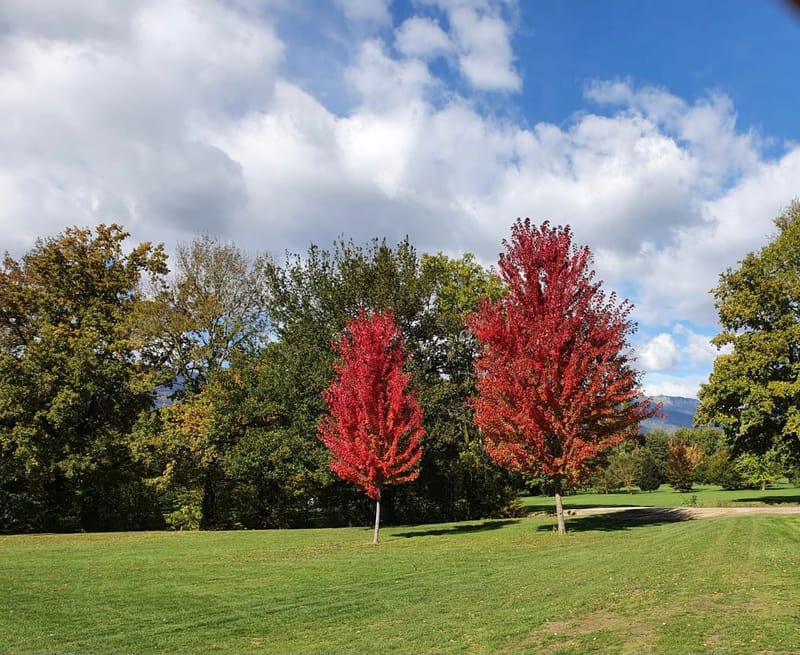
[{"left": 0, "top": 225, "right": 166, "bottom": 530}]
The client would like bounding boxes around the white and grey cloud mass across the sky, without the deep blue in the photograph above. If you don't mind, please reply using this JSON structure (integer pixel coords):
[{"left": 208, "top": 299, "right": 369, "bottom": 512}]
[{"left": 0, "top": 0, "right": 800, "bottom": 395}]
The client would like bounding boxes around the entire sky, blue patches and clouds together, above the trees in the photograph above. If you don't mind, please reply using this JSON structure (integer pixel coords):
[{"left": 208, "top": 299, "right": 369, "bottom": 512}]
[{"left": 0, "top": 0, "right": 800, "bottom": 396}]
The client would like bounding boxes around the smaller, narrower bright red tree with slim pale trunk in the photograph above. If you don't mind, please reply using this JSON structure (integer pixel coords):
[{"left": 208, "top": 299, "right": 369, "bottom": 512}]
[{"left": 318, "top": 310, "right": 425, "bottom": 544}]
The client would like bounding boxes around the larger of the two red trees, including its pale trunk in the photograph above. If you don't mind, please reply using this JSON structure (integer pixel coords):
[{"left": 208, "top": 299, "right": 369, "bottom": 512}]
[{"left": 468, "top": 219, "right": 658, "bottom": 534}]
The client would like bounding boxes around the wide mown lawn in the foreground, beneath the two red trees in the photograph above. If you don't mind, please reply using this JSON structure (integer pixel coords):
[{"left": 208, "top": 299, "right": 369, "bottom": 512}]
[{"left": 0, "top": 515, "right": 800, "bottom": 653}]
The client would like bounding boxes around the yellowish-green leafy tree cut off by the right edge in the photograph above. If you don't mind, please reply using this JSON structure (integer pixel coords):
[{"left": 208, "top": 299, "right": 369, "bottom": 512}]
[{"left": 696, "top": 201, "right": 800, "bottom": 461}]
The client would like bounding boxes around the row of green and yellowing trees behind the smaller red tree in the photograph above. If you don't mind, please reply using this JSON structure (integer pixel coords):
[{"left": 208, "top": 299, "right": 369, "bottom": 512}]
[{"left": 0, "top": 225, "right": 522, "bottom": 532}]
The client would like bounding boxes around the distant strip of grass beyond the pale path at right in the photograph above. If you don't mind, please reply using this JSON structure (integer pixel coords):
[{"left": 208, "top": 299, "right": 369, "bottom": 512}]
[{"left": 521, "top": 480, "right": 800, "bottom": 512}]
